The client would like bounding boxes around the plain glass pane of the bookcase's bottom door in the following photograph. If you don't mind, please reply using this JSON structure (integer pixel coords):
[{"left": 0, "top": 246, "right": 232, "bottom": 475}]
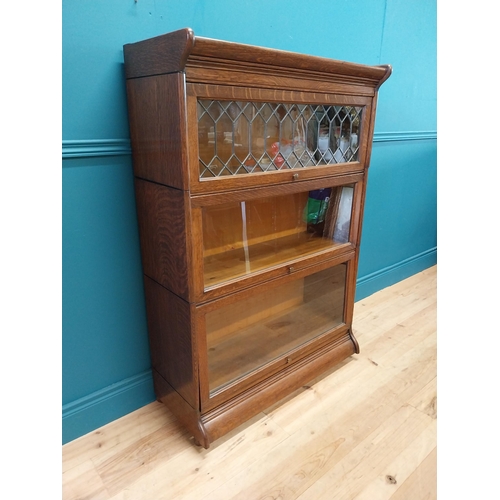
[{"left": 206, "top": 264, "right": 346, "bottom": 393}]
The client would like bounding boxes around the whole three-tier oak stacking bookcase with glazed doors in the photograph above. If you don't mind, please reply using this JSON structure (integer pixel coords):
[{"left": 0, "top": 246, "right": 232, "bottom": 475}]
[{"left": 124, "top": 28, "right": 391, "bottom": 448}]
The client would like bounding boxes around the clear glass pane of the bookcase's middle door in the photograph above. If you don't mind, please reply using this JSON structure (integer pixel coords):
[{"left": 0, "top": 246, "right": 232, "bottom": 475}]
[{"left": 202, "top": 185, "right": 354, "bottom": 287}]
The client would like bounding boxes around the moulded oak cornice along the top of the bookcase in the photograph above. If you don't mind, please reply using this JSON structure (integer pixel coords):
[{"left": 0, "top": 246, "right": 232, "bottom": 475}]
[{"left": 123, "top": 28, "right": 392, "bottom": 95}]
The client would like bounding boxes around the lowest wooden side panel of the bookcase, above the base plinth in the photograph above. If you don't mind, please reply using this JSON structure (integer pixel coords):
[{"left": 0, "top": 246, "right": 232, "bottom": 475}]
[{"left": 144, "top": 276, "right": 199, "bottom": 409}]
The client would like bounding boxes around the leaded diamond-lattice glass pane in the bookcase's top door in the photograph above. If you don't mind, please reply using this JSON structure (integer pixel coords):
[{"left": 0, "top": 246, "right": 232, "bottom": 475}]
[{"left": 198, "top": 99, "right": 363, "bottom": 178}]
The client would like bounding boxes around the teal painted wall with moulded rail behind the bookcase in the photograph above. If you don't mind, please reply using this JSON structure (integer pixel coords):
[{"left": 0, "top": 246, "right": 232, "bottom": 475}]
[{"left": 62, "top": 0, "right": 437, "bottom": 443}]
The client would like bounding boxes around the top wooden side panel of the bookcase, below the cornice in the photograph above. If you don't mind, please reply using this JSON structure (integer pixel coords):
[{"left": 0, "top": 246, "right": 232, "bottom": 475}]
[{"left": 127, "top": 73, "right": 188, "bottom": 189}]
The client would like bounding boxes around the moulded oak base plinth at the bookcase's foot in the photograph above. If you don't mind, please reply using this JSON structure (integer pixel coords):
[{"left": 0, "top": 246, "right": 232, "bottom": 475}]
[{"left": 153, "top": 330, "right": 359, "bottom": 448}]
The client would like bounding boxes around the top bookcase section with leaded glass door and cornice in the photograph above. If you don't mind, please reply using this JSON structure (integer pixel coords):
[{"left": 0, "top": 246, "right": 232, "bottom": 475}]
[{"left": 124, "top": 29, "right": 391, "bottom": 194}]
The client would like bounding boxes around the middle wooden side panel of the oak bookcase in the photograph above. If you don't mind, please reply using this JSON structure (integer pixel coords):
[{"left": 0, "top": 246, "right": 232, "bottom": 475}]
[{"left": 135, "top": 179, "right": 189, "bottom": 300}]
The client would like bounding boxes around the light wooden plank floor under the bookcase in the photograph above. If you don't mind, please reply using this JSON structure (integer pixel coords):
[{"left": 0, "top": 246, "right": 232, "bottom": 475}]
[{"left": 62, "top": 267, "right": 436, "bottom": 500}]
